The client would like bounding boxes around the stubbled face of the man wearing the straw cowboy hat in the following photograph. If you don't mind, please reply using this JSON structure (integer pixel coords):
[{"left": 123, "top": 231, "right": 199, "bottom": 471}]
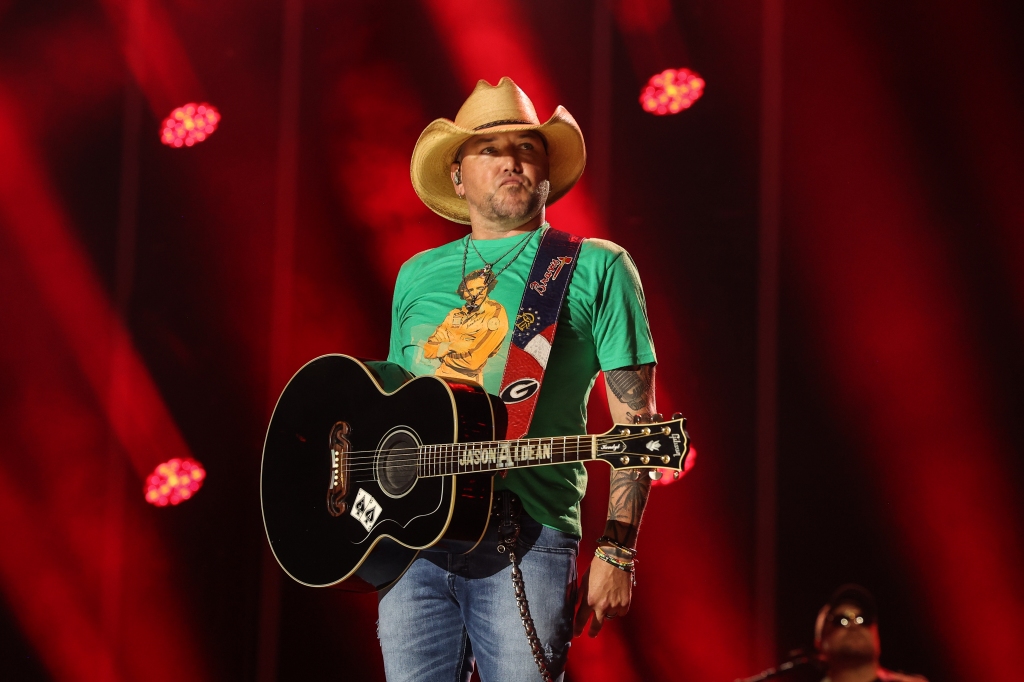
[{"left": 452, "top": 131, "right": 551, "bottom": 226}]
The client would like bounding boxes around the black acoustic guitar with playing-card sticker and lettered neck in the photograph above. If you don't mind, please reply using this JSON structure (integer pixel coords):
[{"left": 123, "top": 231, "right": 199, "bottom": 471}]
[{"left": 260, "top": 355, "right": 689, "bottom": 592}]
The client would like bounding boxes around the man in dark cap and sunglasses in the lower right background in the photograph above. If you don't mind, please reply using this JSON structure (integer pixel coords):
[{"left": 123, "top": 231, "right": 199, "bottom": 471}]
[{"left": 814, "top": 585, "right": 927, "bottom": 682}]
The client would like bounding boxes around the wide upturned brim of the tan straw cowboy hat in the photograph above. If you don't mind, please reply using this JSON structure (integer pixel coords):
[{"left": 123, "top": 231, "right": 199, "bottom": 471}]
[{"left": 409, "top": 106, "right": 587, "bottom": 225}]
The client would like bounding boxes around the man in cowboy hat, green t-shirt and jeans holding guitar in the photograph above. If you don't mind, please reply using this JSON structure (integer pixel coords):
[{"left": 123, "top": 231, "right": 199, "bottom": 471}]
[{"left": 378, "top": 78, "right": 655, "bottom": 682}]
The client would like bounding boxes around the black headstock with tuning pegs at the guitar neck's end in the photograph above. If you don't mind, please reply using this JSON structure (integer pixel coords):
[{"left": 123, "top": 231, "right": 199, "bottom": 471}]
[{"left": 597, "top": 416, "right": 690, "bottom": 478}]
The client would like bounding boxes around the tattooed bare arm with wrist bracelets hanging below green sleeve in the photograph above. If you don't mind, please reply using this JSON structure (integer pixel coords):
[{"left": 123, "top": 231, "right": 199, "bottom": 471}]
[{"left": 574, "top": 365, "right": 656, "bottom": 637}]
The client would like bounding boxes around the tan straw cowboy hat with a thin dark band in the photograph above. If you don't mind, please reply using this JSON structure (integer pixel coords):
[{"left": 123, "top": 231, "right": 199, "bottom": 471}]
[{"left": 410, "top": 77, "right": 587, "bottom": 225}]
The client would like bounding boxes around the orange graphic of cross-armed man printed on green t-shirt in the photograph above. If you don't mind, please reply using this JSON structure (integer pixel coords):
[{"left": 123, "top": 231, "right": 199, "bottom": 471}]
[{"left": 423, "top": 268, "right": 509, "bottom": 386}]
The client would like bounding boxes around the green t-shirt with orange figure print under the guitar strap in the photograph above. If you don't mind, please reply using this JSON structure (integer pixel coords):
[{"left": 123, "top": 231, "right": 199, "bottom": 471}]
[{"left": 388, "top": 223, "right": 655, "bottom": 537}]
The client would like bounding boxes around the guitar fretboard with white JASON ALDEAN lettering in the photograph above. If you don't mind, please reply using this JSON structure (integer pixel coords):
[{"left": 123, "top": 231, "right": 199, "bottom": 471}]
[{"left": 417, "top": 434, "right": 598, "bottom": 477}]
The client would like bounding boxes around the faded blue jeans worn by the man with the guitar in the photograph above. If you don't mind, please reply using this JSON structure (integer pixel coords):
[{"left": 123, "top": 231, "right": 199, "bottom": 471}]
[{"left": 377, "top": 513, "right": 580, "bottom": 682}]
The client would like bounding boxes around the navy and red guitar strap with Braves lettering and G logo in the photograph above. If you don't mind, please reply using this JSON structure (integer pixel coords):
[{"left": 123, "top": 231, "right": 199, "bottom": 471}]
[{"left": 499, "top": 227, "right": 583, "bottom": 439}]
